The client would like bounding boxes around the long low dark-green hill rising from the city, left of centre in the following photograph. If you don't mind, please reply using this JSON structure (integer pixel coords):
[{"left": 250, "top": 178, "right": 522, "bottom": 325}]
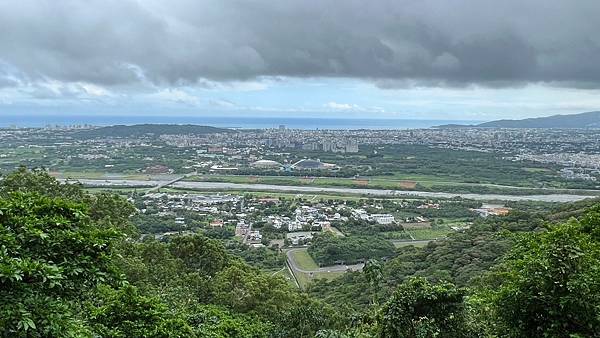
[{"left": 75, "top": 124, "right": 235, "bottom": 138}]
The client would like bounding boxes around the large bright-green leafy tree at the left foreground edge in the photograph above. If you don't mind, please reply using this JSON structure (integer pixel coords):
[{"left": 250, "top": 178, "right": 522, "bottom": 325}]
[{"left": 0, "top": 192, "right": 119, "bottom": 336}]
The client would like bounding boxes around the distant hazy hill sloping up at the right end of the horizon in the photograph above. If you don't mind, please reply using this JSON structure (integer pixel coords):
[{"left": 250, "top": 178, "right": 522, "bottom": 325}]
[{"left": 436, "top": 111, "right": 600, "bottom": 128}]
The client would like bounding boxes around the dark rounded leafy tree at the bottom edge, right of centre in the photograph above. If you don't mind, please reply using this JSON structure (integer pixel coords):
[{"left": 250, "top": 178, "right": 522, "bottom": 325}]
[{"left": 377, "top": 278, "right": 470, "bottom": 338}]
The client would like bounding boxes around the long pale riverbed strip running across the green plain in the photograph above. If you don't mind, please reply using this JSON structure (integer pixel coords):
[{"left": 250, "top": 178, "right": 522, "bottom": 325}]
[{"left": 70, "top": 179, "right": 595, "bottom": 202}]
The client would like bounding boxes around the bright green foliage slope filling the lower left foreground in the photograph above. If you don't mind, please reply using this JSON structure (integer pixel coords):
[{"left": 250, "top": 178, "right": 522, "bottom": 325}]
[{"left": 0, "top": 170, "right": 340, "bottom": 337}]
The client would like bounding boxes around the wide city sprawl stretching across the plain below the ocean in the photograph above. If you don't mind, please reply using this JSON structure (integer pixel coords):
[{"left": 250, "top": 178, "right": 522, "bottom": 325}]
[{"left": 5, "top": 126, "right": 600, "bottom": 181}]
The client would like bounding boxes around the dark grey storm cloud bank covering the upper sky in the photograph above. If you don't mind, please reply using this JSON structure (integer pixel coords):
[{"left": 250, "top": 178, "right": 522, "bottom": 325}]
[{"left": 0, "top": 0, "right": 600, "bottom": 87}]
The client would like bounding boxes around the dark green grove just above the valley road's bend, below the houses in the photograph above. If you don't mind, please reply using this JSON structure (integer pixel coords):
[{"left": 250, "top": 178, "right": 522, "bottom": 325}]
[{"left": 308, "top": 233, "right": 395, "bottom": 265}]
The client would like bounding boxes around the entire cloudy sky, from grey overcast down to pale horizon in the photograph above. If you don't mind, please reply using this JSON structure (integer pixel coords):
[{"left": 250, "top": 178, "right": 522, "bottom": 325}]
[{"left": 0, "top": 0, "right": 600, "bottom": 121}]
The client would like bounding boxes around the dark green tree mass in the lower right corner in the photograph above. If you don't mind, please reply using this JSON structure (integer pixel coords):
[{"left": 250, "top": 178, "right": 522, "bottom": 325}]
[{"left": 473, "top": 207, "right": 600, "bottom": 337}]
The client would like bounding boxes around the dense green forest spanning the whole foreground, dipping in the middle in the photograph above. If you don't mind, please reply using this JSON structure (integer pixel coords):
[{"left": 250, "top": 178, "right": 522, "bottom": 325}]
[{"left": 0, "top": 169, "right": 600, "bottom": 337}]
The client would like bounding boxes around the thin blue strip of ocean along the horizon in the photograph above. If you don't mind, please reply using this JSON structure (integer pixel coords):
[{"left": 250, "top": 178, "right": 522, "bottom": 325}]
[{"left": 0, "top": 115, "right": 481, "bottom": 130}]
